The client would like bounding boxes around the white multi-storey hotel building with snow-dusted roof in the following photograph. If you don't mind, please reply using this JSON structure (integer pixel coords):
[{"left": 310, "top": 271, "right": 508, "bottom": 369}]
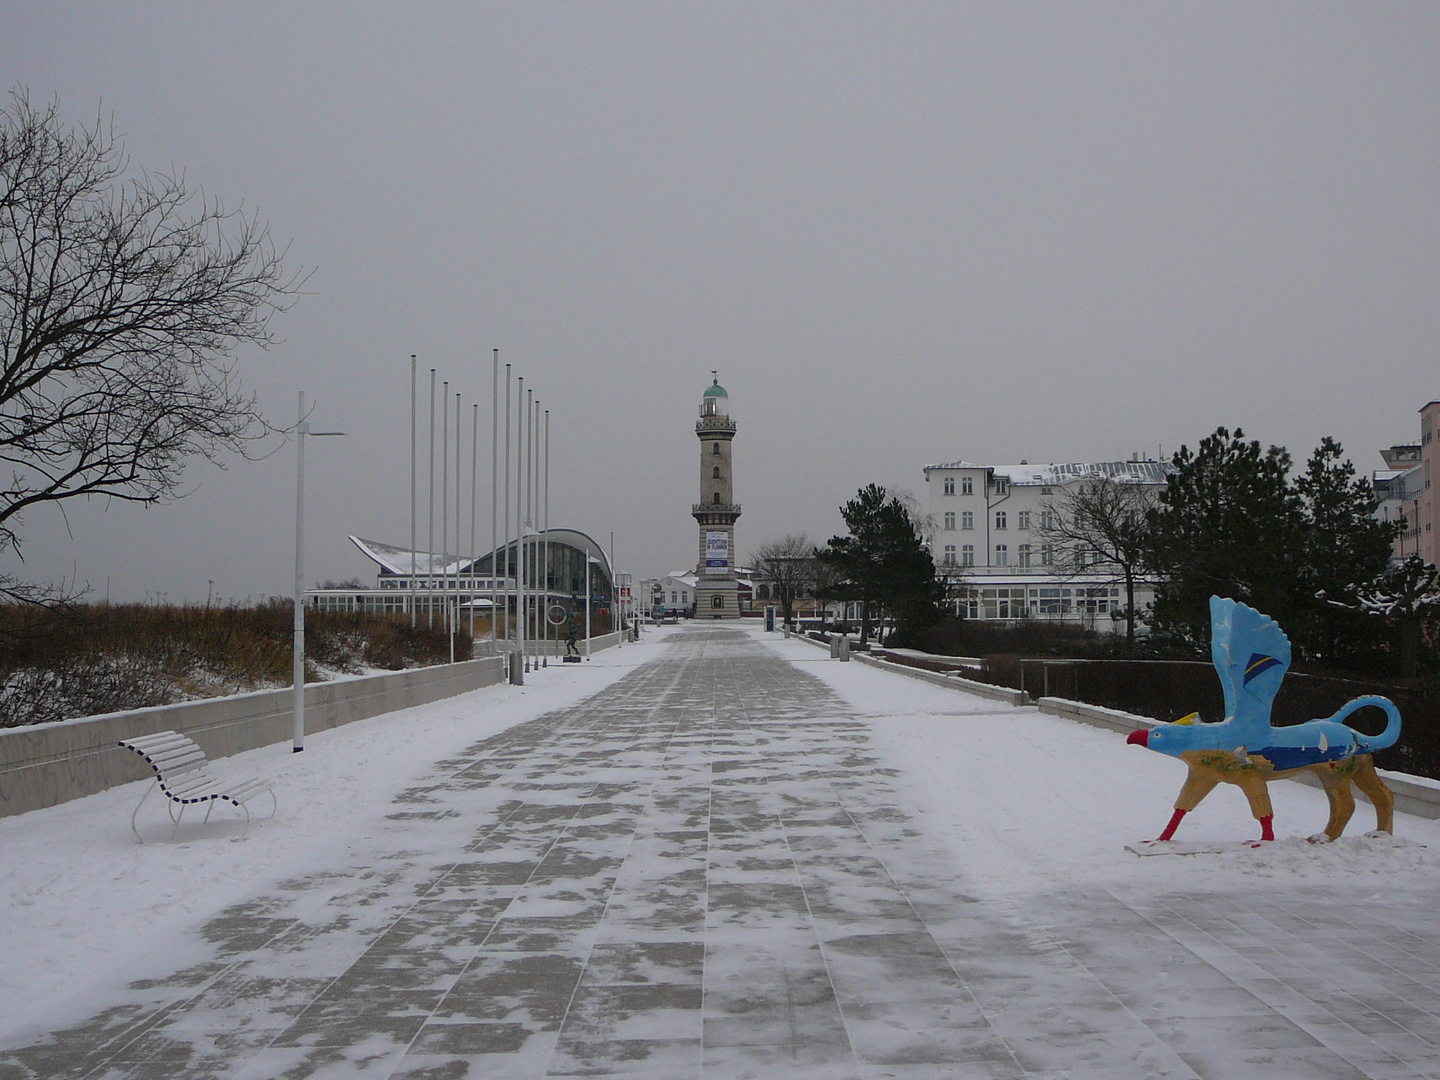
[{"left": 924, "top": 459, "right": 1171, "bottom": 634}]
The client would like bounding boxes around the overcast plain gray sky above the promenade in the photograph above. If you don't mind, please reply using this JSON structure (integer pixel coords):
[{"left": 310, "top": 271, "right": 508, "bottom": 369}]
[{"left": 0, "top": 3, "right": 1440, "bottom": 600}]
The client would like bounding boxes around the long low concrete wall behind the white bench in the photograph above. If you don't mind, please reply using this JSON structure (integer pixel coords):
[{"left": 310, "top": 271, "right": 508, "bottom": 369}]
[{"left": 0, "top": 656, "right": 506, "bottom": 816}]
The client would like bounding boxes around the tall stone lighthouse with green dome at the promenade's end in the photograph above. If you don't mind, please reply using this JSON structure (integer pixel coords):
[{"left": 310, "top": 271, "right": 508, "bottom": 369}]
[{"left": 690, "top": 372, "right": 740, "bottom": 619}]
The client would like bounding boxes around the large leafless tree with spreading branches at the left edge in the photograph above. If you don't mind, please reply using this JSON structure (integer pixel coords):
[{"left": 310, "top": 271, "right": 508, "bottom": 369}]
[{"left": 0, "top": 89, "right": 302, "bottom": 599}]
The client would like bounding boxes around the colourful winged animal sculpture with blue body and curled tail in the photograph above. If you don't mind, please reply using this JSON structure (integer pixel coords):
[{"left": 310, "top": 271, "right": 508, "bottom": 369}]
[{"left": 1126, "top": 596, "right": 1400, "bottom": 844}]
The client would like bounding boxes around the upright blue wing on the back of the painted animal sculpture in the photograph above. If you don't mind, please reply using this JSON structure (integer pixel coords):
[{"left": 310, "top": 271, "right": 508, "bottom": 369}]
[{"left": 1210, "top": 596, "right": 1290, "bottom": 747}]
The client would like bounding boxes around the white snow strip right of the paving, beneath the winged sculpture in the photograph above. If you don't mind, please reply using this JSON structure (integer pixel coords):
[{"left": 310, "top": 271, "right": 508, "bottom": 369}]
[{"left": 753, "top": 631, "right": 1440, "bottom": 900}]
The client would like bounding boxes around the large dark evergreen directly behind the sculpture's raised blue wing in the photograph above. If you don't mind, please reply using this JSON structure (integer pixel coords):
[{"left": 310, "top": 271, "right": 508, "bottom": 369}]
[{"left": 1149, "top": 428, "right": 1306, "bottom": 651}]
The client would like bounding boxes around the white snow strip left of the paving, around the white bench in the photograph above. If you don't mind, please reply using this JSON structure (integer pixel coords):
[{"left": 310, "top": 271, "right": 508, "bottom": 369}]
[{"left": 0, "top": 628, "right": 674, "bottom": 1034}]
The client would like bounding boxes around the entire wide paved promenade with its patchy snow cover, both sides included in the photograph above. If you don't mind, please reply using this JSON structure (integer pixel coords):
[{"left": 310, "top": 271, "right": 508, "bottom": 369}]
[{"left": 0, "top": 625, "right": 1440, "bottom": 1080}]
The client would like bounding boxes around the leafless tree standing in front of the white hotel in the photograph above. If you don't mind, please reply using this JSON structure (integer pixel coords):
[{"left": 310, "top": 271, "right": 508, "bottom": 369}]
[{"left": 1040, "top": 475, "right": 1156, "bottom": 652}]
